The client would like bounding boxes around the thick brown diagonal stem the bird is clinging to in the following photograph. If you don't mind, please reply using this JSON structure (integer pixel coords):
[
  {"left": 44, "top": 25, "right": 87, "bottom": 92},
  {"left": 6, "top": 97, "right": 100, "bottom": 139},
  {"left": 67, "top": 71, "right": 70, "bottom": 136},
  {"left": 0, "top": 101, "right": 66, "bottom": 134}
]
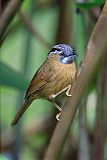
[{"left": 44, "top": 0, "right": 107, "bottom": 160}]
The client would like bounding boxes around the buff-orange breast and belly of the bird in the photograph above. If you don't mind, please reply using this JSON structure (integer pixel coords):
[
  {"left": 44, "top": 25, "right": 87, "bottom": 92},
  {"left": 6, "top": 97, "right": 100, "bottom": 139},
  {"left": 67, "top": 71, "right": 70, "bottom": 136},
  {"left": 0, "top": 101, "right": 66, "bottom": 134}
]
[{"left": 38, "top": 61, "right": 76, "bottom": 98}]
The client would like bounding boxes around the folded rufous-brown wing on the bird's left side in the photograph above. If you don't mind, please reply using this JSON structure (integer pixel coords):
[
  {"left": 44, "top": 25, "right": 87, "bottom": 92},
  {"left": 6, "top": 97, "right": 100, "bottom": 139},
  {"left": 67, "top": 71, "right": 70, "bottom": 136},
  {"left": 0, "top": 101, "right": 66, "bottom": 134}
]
[{"left": 25, "top": 60, "right": 51, "bottom": 98}]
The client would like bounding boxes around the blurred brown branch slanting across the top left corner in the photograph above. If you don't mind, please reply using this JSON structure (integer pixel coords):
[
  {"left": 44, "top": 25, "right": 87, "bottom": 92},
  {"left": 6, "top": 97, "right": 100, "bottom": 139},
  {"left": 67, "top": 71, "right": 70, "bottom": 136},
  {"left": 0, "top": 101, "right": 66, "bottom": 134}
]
[{"left": 0, "top": 0, "right": 23, "bottom": 39}]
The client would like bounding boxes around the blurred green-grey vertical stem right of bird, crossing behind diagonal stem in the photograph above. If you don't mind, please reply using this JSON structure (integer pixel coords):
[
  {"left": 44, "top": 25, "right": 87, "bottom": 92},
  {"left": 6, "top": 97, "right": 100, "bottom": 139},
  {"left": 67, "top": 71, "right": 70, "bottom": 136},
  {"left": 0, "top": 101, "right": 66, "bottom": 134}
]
[{"left": 74, "top": 0, "right": 90, "bottom": 160}]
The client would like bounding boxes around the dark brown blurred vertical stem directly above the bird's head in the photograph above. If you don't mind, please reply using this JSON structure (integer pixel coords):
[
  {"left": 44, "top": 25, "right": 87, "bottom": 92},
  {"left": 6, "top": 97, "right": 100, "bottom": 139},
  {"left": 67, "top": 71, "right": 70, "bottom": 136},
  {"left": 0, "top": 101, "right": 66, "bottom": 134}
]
[{"left": 56, "top": 0, "right": 73, "bottom": 44}]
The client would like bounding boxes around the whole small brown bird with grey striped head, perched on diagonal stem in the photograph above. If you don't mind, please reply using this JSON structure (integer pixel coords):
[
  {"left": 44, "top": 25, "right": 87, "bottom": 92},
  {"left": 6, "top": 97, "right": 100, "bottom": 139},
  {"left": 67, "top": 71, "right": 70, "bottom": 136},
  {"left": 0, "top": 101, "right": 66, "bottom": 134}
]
[{"left": 11, "top": 44, "right": 77, "bottom": 126}]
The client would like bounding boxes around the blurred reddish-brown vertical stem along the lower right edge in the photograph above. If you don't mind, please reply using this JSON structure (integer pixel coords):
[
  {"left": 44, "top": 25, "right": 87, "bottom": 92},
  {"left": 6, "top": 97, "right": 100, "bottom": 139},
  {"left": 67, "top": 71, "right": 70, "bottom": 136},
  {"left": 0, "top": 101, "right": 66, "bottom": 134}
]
[{"left": 95, "top": 53, "right": 107, "bottom": 160}]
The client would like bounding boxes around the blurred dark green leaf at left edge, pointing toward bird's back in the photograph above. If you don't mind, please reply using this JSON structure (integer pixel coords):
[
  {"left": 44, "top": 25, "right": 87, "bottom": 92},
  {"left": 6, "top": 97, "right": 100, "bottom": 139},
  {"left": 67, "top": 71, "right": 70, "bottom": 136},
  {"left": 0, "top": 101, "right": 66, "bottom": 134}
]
[{"left": 0, "top": 62, "right": 29, "bottom": 91}]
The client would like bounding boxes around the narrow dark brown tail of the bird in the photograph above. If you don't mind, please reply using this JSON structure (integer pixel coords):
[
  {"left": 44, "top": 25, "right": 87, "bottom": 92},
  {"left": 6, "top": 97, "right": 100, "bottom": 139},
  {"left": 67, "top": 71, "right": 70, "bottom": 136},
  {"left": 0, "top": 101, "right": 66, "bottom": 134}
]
[{"left": 11, "top": 99, "right": 32, "bottom": 127}]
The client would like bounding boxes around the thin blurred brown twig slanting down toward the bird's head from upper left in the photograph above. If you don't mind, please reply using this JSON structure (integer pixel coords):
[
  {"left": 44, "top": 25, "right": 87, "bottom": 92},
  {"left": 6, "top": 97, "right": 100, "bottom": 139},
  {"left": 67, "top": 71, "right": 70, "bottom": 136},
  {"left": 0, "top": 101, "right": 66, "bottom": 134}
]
[{"left": 19, "top": 11, "right": 51, "bottom": 49}]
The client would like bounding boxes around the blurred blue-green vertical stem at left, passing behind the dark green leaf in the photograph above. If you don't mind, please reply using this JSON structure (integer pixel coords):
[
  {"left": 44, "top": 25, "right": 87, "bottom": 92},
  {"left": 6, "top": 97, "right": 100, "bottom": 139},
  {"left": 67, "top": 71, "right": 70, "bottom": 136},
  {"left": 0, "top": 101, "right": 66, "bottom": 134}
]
[{"left": 14, "top": 1, "right": 35, "bottom": 160}]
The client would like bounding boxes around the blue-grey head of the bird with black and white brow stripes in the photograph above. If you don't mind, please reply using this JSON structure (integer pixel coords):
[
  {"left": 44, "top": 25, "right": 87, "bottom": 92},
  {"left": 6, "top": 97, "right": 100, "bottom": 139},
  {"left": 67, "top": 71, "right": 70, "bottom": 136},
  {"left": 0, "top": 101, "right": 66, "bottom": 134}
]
[{"left": 48, "top": 44, "right": 77, "bottom": 64}]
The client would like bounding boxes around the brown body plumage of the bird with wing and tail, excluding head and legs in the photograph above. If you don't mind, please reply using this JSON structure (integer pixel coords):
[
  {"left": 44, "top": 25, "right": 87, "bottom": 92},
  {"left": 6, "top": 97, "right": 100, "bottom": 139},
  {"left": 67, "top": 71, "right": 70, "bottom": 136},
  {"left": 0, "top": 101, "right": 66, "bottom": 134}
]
[{"left": 11, "top": 54, "right": 76, "bottom": 126}]
